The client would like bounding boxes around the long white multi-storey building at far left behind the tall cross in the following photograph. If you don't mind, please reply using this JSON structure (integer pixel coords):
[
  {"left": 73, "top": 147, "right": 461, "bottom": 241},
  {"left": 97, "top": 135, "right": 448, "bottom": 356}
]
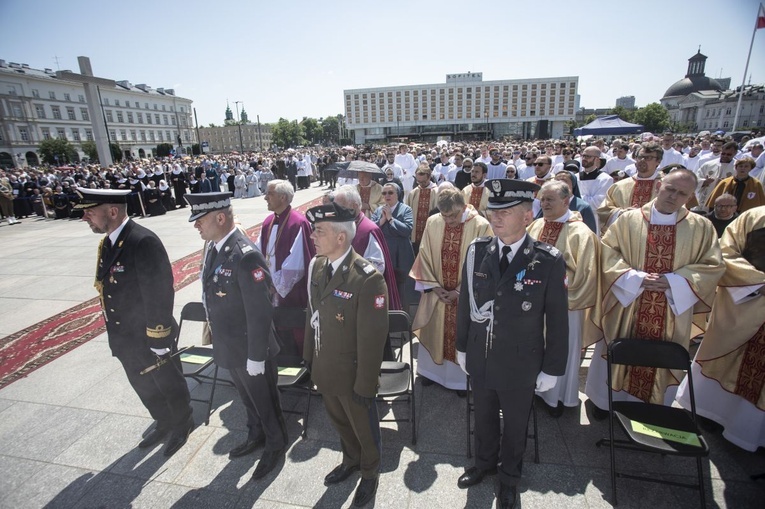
[{"left": 0, "top": 56, "right": 196, "bottom": 166}]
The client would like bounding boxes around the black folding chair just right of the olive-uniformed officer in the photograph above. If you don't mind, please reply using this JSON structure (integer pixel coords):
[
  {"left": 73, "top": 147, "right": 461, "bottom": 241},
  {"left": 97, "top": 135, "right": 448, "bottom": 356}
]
[{"left": 377, "top": 310, "right": 417, "bottom": 445}]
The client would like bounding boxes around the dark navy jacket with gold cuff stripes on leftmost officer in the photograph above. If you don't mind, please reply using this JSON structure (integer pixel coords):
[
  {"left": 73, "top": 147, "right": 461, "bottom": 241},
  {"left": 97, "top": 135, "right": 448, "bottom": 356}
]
[{"left": 96, "top": 219, "right": 178, "bottom": 357}]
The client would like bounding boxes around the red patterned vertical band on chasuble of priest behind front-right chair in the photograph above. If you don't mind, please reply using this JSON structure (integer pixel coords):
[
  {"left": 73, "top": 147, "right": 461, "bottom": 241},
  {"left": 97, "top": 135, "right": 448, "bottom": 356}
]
[{"left": 627, "top": 224, "right": 677, "bottom": 402}]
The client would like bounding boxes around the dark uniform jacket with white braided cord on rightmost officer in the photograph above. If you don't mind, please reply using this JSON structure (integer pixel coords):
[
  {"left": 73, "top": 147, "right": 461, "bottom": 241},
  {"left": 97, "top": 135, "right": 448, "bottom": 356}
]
[{"left": 457, "top": 235, "right": 568, "bottom": 390}]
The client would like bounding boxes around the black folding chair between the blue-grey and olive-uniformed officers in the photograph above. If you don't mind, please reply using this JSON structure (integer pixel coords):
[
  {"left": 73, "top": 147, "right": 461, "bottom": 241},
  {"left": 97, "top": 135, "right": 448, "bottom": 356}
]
[{"left": 273, "top": 307, "right": 313, "bottom": 438}]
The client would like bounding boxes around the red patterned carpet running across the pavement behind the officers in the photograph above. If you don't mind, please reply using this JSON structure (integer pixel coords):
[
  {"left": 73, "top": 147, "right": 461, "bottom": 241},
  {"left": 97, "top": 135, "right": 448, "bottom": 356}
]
[{"left": 0, "top": 198, "right": 321, "bottom": 388}]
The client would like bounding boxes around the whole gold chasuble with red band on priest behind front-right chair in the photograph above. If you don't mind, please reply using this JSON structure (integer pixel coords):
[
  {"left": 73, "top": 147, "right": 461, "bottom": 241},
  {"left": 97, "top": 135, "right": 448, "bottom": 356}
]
[{"left": 589, "top": 201, "right": 724, "bottom": 404}]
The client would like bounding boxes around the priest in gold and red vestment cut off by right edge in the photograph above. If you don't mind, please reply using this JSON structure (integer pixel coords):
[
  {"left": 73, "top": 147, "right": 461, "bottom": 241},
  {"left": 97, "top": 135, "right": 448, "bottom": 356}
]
[{"left": 677, "top": 206, "right": 765, "bottom": 452}]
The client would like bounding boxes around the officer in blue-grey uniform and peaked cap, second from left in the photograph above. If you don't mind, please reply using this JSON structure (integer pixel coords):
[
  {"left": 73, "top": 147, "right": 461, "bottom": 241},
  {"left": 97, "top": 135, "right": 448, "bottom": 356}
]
[{"left": 184, "top": 193, "right": 287, "bottom": 479}]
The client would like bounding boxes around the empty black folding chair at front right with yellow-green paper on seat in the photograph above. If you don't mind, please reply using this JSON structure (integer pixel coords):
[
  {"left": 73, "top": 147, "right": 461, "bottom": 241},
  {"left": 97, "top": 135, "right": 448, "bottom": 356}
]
[{"left": 596, "top": 339, "right": 709, "bottom": 507}]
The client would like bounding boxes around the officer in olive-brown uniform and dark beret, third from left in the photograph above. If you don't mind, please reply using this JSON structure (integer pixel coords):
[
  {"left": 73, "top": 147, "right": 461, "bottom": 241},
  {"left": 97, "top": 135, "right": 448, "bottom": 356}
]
[{"left": 303, "top": 203, "right": 388, "bottom": 507}]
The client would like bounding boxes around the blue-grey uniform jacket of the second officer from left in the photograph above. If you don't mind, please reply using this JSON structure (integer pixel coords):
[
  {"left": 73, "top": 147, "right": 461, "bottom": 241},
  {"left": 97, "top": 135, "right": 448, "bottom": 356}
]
[{"left": 202, "top": 229, "right": 279, "bottom": 368}]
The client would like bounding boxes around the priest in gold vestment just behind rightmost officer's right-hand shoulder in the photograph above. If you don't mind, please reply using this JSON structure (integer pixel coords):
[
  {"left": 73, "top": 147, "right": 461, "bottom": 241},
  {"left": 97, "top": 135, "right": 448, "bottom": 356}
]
[{"left": 527, "top": 180, "right": 600, "bottom": 417}]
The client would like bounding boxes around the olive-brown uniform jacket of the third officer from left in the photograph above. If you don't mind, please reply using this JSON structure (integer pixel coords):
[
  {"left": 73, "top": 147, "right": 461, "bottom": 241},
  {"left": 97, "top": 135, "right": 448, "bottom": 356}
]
[{"left": 303, "top": 249, "right": 388, "bottom": 398}]
